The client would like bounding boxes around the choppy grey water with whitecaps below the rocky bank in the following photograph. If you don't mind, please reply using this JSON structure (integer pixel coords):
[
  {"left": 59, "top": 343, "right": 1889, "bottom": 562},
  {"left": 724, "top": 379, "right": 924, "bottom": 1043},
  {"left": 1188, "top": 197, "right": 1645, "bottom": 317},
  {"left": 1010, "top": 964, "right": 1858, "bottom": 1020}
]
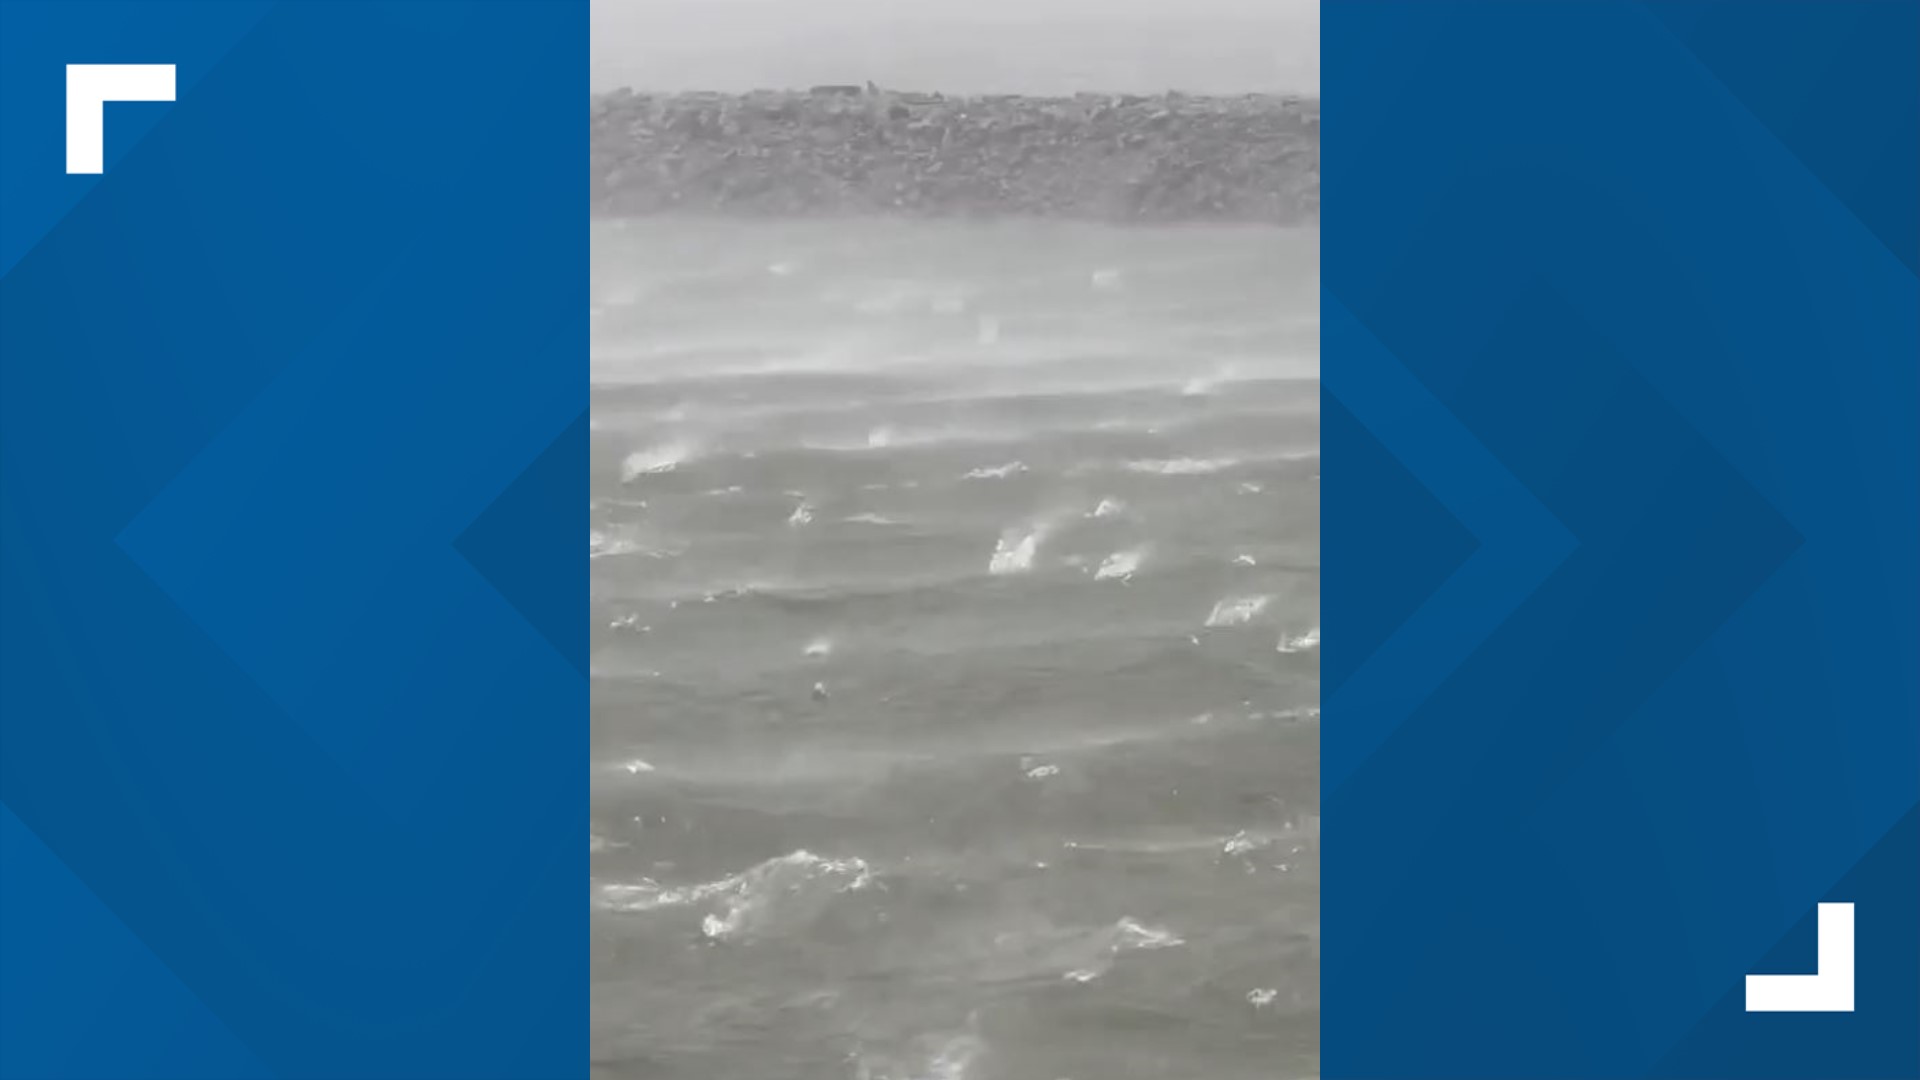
[{"left": 589, "top": 221, "right": 1319, "bottom": 1080}]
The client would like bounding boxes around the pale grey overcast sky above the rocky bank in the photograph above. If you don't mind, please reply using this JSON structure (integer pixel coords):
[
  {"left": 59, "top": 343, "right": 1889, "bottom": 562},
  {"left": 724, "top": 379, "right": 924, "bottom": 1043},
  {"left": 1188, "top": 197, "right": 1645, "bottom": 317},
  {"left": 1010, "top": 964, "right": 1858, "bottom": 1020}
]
[{"left": 591, "top": 0, "right": 1319, "bottom": 94}]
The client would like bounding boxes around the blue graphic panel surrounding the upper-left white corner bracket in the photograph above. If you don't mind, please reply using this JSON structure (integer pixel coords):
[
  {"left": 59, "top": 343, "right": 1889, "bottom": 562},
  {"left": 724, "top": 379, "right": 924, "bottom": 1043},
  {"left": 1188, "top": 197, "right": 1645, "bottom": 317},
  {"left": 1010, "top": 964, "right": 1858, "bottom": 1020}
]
[{"left": 0, "top": 0, "right": 588, "bottom": 1080}]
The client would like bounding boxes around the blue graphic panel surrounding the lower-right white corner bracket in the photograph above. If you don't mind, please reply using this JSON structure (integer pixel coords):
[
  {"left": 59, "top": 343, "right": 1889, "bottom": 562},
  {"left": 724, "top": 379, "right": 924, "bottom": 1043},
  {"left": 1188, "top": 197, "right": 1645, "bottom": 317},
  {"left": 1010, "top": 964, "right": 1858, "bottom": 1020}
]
[{"left": 1321, "top": 0, "right": 1920, "bottom": 1080}]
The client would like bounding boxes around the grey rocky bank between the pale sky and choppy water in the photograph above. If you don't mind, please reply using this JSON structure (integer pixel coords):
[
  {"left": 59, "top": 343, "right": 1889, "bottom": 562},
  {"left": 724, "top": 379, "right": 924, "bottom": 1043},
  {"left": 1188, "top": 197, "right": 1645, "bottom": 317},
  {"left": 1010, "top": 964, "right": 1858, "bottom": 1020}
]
[{"left": 591, "top": 85, "right": 1319, "bottom": 225}]
